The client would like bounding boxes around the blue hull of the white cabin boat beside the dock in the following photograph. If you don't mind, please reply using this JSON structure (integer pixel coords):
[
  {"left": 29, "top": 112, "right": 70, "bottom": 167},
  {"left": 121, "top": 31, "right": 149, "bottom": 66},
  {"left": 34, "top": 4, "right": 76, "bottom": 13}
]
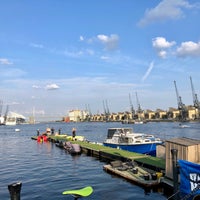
[{"left": 103, "top": 142, "right": 158, "bottom": 156}]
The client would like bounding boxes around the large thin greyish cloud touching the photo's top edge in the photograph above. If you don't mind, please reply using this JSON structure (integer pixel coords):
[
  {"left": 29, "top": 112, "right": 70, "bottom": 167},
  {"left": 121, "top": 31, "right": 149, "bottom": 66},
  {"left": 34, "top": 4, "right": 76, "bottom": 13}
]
[{"left": 138, "top": 0, "right": 198, "bottom": 26}]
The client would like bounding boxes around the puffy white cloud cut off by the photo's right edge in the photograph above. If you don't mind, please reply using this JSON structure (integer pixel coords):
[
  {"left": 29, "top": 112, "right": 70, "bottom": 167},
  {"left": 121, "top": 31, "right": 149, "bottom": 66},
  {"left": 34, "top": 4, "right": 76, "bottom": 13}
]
[{"left": 176, "top": 41, "right": 200, "bottom": 57}]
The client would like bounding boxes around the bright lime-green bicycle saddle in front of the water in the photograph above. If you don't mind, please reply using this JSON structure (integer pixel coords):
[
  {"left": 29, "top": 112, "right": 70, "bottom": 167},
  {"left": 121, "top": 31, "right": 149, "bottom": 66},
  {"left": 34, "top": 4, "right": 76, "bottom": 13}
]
[{"left": 62, "top": 186, "right": 93, "bottom": 199}]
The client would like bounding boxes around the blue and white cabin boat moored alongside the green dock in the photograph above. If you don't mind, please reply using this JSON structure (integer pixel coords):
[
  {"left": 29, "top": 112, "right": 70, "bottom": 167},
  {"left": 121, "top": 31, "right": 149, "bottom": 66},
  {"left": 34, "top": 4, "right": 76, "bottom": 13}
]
[{"left": 103, "top": 128, "right": 163, "bottom": 156}]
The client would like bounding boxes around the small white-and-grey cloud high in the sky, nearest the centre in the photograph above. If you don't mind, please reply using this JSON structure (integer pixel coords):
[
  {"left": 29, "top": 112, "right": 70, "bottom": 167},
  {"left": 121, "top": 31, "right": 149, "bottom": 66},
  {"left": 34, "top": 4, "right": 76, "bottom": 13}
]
[{"left": 97, "top": 34, "right": 119, "bottom": 50}]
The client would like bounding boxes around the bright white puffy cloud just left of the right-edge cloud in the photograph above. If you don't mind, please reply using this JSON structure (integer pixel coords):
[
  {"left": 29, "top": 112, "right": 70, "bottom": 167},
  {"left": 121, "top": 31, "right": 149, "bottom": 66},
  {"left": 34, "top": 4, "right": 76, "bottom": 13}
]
[{"left": 152, "top": 37, "right": 176, "bottom": 58}]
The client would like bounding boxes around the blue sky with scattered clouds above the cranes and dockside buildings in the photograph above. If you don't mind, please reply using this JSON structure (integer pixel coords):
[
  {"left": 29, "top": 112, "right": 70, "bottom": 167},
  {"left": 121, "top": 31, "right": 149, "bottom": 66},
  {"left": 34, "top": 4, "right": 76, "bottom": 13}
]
[{"left": 0, "top": 0, "right": 200, "bottom": 117}]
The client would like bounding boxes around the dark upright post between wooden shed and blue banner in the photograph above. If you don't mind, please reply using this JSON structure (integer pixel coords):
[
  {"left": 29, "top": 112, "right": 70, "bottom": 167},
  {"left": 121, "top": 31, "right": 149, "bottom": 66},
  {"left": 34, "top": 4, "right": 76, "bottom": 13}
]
[{"left": 171, "top": 149, "right": 179, "bottom": 200}]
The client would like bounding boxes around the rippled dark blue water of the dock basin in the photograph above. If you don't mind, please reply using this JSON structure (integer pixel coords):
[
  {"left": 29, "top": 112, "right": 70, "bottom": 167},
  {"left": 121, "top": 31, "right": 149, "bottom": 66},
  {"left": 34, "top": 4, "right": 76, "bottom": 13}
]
[{"left": 0, "top": 123, "right": 200, "bottom": 200}]
